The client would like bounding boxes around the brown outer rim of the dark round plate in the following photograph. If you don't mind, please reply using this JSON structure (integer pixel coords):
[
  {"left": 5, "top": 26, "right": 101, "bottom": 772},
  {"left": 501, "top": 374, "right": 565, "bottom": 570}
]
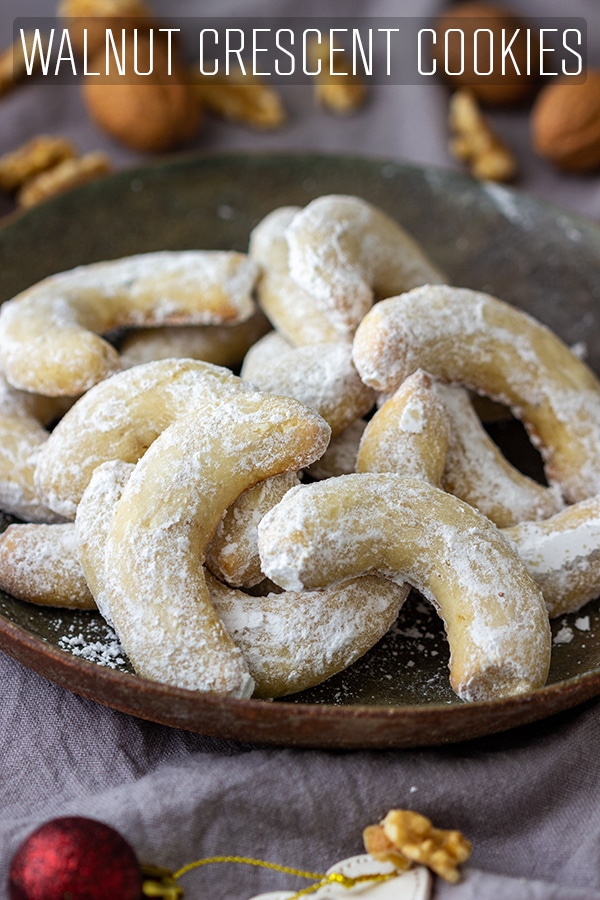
[{"left": 0, "top": 150, "right": 600, "bottom": 749}]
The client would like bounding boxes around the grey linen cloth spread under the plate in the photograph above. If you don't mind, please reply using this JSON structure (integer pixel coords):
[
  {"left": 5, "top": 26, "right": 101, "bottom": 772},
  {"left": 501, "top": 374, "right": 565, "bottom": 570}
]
[{"left": 0, "top": 0, "right": 600, "bottom": 900}]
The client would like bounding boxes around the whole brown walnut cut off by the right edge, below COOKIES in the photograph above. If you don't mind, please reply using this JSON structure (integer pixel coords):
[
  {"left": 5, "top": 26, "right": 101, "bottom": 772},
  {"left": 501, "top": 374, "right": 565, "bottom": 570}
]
[{"left": 531, "top": 69, "right": 600, "bottom": 172}]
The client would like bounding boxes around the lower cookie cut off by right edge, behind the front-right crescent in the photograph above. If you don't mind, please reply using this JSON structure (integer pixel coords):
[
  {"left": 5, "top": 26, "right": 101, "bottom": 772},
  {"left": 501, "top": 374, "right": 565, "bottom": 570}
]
[{"left": 503, "top": 497, "right": 600, "bottom": 618}]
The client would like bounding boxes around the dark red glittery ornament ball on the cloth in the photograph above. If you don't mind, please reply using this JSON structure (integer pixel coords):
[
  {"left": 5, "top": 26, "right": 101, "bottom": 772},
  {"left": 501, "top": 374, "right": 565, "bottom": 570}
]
[{"left": 9, "top": 816, "right": 142, "bottom": 900}]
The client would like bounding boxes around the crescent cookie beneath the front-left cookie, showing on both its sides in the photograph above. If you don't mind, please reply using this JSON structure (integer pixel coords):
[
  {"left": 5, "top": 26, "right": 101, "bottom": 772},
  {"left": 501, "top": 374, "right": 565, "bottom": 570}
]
[{"left": 75, "top": 461, "right": 407, "bottom": 698}]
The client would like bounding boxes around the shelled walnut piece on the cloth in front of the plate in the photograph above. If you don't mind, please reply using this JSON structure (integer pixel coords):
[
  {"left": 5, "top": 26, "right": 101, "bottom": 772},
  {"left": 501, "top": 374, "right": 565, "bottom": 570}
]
[{"left": 363, "top": 809, "right": 471, "bottom": 883}]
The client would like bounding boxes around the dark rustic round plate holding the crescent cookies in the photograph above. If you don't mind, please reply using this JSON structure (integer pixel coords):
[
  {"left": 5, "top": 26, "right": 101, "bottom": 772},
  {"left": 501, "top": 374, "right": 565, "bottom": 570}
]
[{"left": 0, "top": 155, "right": 600, "bottom": 748}]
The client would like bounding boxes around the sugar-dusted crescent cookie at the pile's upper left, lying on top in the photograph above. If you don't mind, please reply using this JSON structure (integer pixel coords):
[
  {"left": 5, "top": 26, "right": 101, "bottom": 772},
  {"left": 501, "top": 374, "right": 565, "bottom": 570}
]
[{"left": 0, "top": 250, "right": 258, "bottom": 396}]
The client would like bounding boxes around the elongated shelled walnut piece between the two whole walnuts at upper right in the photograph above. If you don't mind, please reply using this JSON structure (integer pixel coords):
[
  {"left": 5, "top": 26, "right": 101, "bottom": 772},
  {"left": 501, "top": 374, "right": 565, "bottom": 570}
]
[{"left": 448, "top": 89, "right": 517, "bottom": 181}]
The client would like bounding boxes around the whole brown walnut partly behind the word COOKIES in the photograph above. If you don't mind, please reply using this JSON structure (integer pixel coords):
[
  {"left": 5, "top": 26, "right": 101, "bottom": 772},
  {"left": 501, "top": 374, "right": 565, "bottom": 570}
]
[{"left": 434, "top": 2, "right": 539, "bottom": 106}]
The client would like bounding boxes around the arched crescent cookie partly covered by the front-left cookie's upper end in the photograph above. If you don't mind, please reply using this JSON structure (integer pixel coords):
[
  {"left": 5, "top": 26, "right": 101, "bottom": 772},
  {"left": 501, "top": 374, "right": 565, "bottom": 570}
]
[{"left": 35, "top": 359, "right": 254, "bottom": 519}]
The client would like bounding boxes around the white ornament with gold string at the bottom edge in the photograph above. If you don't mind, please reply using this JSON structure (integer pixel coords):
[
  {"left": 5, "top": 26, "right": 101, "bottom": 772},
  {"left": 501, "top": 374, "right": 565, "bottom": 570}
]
[{"left": 250, "top": 853, "right": 432, "bottom": 900}]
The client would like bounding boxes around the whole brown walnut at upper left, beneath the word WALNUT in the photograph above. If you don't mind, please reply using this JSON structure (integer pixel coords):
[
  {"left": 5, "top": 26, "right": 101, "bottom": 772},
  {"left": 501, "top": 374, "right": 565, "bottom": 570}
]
[{"left": 83, "top": 34, "right": 202, "bottom": 153}]
